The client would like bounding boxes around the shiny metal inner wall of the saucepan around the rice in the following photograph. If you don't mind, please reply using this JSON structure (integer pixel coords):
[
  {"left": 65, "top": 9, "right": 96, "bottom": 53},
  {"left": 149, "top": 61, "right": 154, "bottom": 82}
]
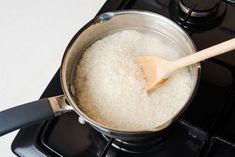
[{"left": 61, "top": 11, "right": 199, "bottom": 133}]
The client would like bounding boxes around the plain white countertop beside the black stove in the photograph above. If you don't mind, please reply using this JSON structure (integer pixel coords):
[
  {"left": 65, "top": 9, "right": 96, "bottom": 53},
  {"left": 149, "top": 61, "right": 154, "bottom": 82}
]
[{"left": 0, "top": 0, "right": 105, "bottom": 157}]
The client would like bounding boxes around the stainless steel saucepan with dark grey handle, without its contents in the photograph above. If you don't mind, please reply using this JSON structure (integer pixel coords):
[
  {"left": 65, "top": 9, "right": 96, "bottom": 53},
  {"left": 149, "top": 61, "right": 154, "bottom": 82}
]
[{"left": 0, "top": 10, "right": 200, "bottom": 141}]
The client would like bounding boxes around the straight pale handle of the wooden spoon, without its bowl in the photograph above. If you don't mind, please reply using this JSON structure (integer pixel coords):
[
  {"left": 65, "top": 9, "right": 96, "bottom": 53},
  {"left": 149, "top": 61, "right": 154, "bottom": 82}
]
[{"left": 171, "top": 38, "right": 235, "bottom": 70}]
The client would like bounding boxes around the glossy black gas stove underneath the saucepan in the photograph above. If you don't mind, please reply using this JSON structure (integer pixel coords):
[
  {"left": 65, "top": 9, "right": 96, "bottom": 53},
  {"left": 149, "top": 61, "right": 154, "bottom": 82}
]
[{"left": 12, "top": 0, "right": 235, "bottom": 157}]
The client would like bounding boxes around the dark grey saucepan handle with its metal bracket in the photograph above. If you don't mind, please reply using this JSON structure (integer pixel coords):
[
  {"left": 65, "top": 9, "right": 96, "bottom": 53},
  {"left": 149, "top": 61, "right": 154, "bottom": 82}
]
[{"left": 0, "top": 96, "right": 72, "bottom": 136}]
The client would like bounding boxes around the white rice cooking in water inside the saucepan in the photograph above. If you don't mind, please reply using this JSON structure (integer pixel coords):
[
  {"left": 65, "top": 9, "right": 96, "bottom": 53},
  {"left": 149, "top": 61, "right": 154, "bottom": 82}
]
[{"left": 75, "top": 30, "right": 192, "bottom": 131}]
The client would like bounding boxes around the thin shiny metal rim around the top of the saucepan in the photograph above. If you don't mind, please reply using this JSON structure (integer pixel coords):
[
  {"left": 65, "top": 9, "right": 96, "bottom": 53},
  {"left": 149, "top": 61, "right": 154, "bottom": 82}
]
[{"left": 60, "top": 10, "right": 201, "bottom": 135}]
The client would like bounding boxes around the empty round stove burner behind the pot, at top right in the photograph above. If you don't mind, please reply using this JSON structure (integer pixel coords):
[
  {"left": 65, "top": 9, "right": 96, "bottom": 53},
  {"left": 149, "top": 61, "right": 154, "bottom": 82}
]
[{"left": 169, "top": 0, "right": 226, "bottom": 31}]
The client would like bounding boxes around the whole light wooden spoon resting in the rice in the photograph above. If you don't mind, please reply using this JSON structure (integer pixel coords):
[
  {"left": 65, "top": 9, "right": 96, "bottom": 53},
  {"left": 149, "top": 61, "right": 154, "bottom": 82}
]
[{"left": 136, "top": 38, "right": 235, "bottom": 92}]
